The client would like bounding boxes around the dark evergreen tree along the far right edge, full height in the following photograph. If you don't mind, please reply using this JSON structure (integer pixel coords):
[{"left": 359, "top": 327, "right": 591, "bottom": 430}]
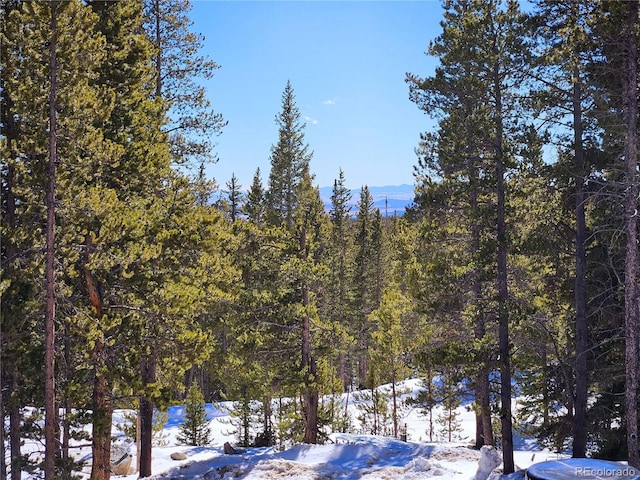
[{"left": 590, "top": 1, "right": 640, "bottom": 466}]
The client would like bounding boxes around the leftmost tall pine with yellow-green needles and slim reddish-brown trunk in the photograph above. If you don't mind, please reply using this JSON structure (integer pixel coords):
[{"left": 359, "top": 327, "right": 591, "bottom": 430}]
[{"left": 2, "top": 2, "right": 108, "bottom": 478}]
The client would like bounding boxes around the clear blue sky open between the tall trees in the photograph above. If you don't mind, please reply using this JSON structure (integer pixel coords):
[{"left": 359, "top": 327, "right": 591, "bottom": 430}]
[{"left": 191, "top": 0, "right": 442, "bottom": 188}]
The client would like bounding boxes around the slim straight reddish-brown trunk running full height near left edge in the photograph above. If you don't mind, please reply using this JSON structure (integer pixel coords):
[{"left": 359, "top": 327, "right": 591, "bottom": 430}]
[{"left": 43, "top": 0, "right": 58, "bottom": 480}]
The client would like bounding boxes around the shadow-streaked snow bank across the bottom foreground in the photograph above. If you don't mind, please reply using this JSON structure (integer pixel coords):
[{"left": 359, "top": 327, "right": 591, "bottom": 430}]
[{"left": 129, "top": 434, "right": 557, "bottom": 480}]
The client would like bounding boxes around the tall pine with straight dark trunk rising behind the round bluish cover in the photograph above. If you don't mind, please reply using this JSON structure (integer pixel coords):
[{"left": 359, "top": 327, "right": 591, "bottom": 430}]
[{"left": 534, "top": 0, "right": 595, "bottom": 457}]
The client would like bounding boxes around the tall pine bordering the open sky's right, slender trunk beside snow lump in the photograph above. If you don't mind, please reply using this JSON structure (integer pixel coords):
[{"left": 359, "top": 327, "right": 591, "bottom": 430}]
[{"left": 408, "top": 1, "right": 526, "bottom": 473}]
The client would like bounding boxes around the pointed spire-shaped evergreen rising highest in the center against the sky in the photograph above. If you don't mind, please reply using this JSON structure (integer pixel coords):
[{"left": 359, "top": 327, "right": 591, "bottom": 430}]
[{"left": 265, "top": 82, "right": 326, "bottom": 443}]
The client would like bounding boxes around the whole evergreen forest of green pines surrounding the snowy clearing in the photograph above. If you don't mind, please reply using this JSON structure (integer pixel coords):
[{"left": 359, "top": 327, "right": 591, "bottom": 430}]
[{"left": 0, "top": 0, "right": 640, "bottom": 480}]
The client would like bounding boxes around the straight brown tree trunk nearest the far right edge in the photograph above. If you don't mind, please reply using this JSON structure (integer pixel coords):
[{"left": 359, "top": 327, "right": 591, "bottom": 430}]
[{"left": 623, "top": 1, "right": 640, "bottom": 467}]
